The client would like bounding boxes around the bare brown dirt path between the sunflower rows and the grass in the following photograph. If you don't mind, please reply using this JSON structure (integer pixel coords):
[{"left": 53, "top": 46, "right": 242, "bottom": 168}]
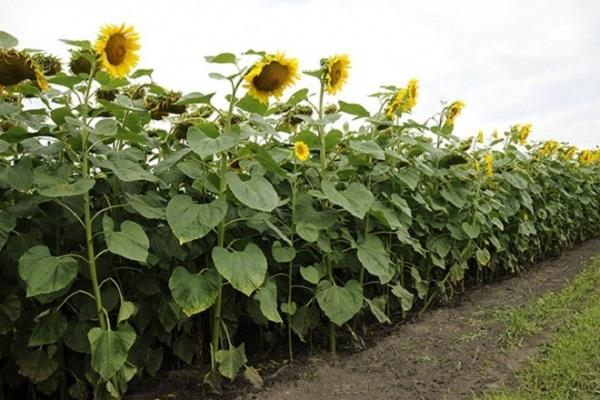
[{"left": 244, "top": 239, "right": 600, "bottom": 400}]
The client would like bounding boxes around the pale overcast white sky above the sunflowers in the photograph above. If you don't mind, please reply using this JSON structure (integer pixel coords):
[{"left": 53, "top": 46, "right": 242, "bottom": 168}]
[{"left": 0, "top": 0, "right": 600, "bottom": 148}]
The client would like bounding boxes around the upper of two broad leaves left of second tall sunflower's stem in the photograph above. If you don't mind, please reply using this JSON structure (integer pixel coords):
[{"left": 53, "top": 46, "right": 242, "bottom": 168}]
[{"left": 167, "top": 195, "right": 227, "bottom": 244}]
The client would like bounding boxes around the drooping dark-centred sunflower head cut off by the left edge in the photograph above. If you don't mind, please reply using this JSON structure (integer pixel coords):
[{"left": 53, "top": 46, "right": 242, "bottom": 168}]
[{"left": 0, "top": 50, "right": 48, "bottom": 90}]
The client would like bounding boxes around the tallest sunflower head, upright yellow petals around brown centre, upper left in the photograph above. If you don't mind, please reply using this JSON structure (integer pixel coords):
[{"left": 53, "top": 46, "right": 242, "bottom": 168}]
[{"left": 96, "top": 24, "right": 140, "bottom": 78}]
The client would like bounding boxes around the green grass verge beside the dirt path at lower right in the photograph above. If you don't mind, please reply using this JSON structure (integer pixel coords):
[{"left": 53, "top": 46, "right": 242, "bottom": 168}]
[{"left": 485, "top": 260, "right": 600, "bottom": 400}]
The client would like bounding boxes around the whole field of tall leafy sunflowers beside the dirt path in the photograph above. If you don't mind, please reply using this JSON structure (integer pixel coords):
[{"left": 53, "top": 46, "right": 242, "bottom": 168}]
[{"left": 0, "top": 25, "right": 600, "bottom": 399}]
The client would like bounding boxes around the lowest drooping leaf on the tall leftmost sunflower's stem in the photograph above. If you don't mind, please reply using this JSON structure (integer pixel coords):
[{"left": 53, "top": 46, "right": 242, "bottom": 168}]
[{"left": 88, "top": 325, "right": 136, "bottom": 381}]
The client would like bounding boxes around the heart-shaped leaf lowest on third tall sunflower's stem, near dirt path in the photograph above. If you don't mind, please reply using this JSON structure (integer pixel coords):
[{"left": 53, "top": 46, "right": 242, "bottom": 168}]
[{"left": 317, "top": 279, "right": 363, "bottom": 326}]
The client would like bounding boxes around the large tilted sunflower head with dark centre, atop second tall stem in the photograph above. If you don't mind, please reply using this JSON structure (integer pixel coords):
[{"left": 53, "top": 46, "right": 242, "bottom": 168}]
[{"left": 244, "top": 53, "right": 298, "bottom": 104}]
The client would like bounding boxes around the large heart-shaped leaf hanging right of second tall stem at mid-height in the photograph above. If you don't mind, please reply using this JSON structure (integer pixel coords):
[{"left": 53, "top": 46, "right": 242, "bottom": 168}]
[{"left": 212, "top": 243, "right": 267, "bottom": 296}]
